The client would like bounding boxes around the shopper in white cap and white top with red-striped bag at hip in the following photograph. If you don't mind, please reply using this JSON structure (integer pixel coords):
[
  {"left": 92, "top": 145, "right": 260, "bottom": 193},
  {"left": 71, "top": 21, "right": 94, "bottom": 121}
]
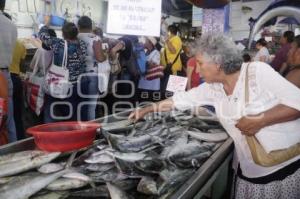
[{"left": 138, "top": 37, "right": 160, "bottom": 102}]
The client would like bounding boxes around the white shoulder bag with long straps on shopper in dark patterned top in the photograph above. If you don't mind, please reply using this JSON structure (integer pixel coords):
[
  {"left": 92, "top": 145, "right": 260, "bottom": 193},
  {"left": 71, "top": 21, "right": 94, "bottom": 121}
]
[{"left": 45, "top": 41, "right": 72, "bottom": 99}]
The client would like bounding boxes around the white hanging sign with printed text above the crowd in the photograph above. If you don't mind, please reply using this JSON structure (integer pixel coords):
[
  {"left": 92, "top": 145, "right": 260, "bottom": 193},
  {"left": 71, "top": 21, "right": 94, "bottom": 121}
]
[{"left": 107, "top": 0, "right": 162, "bottom": 36}]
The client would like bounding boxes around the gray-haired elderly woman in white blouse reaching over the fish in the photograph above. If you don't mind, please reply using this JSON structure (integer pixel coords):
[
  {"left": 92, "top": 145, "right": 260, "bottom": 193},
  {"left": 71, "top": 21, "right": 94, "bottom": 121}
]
[{"left": 129, "top": 35, "right": 300, "bottom": 199}]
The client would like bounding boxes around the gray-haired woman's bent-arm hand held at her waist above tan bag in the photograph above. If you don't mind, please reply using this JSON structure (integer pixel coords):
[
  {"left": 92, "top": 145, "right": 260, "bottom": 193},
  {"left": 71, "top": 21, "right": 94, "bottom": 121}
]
[{"left": 235, "top": 115, "right": 265, "bottom": 136}]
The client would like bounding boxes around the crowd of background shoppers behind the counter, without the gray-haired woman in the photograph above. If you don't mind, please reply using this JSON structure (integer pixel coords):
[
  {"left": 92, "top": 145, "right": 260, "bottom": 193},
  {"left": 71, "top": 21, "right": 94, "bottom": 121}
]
[{"left": 0, "top": 1, "right": 300, "bottom": 145}]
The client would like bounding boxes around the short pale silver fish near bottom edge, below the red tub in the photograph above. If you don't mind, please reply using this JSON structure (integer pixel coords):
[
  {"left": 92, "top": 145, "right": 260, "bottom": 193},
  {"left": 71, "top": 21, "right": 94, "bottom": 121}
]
[{"left": 46, "top": 178, "right": 88, "bottom": 191}]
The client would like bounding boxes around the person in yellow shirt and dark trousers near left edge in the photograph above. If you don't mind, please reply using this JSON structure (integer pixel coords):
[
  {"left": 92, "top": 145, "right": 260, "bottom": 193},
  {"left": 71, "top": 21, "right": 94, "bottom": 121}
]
[{"left": 9, "top": 40, "right": 26, "bottom": 140}]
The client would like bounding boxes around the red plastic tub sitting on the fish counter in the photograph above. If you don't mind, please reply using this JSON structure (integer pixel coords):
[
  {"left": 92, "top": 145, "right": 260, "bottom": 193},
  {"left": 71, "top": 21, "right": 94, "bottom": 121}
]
[{"left": 27, "top": 122, "right": 100, "bottom": 152}]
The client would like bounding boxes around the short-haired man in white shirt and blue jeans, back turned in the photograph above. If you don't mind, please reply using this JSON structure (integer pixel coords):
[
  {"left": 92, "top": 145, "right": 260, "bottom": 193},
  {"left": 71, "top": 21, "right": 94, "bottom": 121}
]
[{"left": 78, "top": 16, "right": 109, "bottom": 121}]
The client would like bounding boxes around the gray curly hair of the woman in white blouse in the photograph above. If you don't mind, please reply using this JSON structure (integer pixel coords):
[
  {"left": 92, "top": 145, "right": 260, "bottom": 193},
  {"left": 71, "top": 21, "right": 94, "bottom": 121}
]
[{"left": 193, "top": 34, "right": 243, "bottom": 74}]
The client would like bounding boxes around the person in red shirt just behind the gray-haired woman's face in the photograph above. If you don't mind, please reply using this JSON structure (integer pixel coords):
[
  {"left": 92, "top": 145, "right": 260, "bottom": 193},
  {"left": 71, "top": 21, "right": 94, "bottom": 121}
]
[{"left": 187, "top": 57, "right": 202, "bottom": 90}]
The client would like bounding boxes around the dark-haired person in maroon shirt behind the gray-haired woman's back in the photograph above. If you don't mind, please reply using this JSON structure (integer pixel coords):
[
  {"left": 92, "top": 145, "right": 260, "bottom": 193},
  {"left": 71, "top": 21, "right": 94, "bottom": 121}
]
[{"left": 270, "top": 31, "right": 294, "bottom": 71}]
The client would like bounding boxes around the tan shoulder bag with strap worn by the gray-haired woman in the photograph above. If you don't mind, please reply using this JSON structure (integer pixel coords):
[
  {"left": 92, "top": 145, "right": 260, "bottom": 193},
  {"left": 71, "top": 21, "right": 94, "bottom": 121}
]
[{"left": 245, "top": 64, "right": 300, "bottom": 167}]
